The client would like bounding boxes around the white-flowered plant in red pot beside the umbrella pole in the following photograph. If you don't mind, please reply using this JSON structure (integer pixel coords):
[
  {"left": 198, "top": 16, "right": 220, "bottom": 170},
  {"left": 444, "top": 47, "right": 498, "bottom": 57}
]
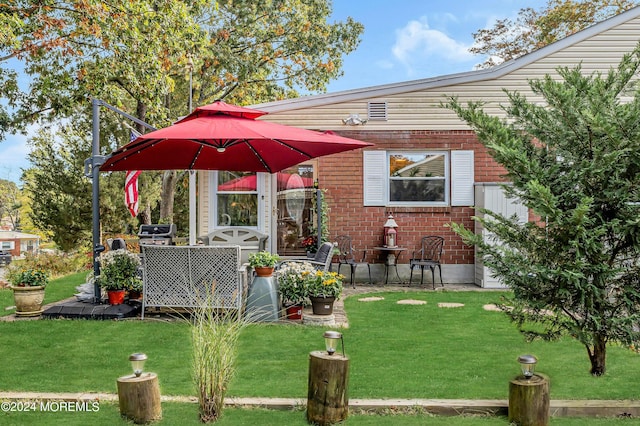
[{"left": 98, "top": 249, "right": 142, "bottom": 305}]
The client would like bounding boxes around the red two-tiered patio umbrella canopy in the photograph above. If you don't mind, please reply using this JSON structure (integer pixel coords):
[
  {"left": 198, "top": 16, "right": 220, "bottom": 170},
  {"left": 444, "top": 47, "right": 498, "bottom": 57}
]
[{"left": 100, "top": 101, "right": 373, "bottom": 173}]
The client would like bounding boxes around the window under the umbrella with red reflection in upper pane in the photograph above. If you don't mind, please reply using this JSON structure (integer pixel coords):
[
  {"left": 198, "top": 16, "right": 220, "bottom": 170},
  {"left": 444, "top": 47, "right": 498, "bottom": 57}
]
[{"left": 215, "top": 171, "right": 258, "bottom": 227}]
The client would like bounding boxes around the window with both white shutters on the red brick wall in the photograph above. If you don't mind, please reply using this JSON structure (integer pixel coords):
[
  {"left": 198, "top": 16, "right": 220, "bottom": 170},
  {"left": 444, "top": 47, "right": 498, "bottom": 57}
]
[{"left": 363, "top": 150, "right": 474, "bottom": 206}]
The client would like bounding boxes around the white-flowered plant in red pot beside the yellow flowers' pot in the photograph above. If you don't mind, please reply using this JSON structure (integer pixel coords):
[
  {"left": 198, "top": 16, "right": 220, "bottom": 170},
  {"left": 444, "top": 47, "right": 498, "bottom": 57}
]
[{"left": 277, "top": 261, "right": 315, "bottom": 320}]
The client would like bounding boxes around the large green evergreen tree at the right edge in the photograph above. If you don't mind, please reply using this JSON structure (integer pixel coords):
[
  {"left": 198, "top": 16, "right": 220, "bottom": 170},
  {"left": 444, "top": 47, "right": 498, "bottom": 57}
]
[{"left": 447, "top": 45, "right": 640, "bottom": 376}]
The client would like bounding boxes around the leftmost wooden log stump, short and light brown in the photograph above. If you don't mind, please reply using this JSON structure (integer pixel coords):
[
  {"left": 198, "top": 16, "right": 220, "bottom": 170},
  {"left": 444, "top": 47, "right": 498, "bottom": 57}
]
[{"left": 118, "top": 373, "right": 162, "bottom": 423}]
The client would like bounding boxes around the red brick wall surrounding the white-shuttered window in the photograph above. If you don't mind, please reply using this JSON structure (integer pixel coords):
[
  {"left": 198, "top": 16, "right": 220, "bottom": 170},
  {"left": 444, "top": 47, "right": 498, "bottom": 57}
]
[{"left": 319, "top": 129, "right": 504, "bottom": 264}]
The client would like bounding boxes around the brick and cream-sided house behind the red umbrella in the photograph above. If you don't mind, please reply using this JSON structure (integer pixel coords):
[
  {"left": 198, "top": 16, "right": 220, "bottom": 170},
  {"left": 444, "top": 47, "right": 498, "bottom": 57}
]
[{"left": 199, "top": 7, "right": 640, "bottom": 283}]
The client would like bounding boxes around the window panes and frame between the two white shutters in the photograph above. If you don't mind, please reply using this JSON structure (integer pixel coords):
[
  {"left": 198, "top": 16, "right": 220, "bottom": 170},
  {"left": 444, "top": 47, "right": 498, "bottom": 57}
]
[{"left": 388, "top": 152, "right": 449, "bottom": 204}]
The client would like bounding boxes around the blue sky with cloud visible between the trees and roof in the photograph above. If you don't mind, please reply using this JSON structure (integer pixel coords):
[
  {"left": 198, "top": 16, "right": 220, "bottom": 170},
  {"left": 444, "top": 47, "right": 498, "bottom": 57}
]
[{"left": 0, "top": 0, "right": 547, "bottom": 182}]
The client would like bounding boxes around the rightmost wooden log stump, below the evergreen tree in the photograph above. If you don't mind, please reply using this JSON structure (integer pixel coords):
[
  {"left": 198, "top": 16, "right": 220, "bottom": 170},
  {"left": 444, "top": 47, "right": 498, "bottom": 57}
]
[{"left": 509, "top": 374, "right": 549, "bottom": 426}]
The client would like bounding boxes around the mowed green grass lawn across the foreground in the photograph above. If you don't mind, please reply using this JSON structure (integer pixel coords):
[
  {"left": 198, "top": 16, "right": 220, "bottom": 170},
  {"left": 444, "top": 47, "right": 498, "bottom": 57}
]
[{"left": 0, "top": 274, "right": 640, "bottom": 425}]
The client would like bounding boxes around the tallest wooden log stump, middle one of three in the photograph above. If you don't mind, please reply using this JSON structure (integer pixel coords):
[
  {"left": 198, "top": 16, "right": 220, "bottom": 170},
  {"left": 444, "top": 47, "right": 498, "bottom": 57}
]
[{"left": 307, "top": 351, "right": 349, "bottom": 426}]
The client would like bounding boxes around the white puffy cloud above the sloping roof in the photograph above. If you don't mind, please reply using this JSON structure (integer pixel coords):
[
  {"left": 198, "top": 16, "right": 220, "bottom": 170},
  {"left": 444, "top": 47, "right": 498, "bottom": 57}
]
[{"left": 392, "top": 17, "right": 474, "bottom": 73}]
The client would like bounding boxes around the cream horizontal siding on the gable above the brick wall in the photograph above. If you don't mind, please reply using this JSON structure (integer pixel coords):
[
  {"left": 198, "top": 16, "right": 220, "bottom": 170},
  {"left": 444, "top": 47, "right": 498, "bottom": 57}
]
[{"left": 256, "top": 12, "right": 640, "bottom": 131}]
